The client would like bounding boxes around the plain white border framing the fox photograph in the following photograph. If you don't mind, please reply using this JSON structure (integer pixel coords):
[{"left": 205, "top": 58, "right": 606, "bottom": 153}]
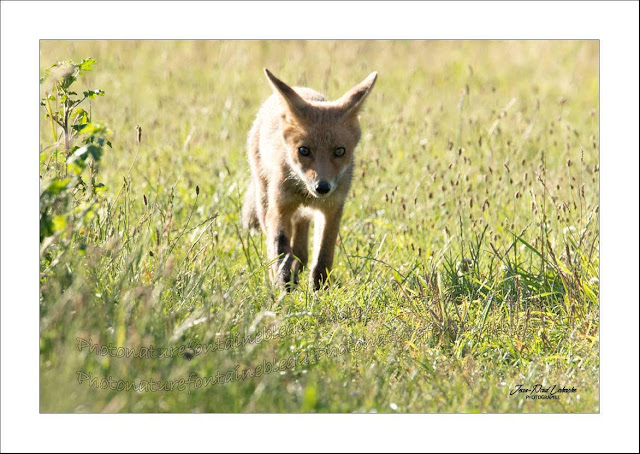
[{"left": 0, "top": 2, "right": 639, "bottom": 452}]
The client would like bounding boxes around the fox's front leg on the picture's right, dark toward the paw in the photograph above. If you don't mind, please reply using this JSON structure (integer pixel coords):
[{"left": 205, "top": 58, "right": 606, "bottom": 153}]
[{"left": 311, "top": 206, "right": 342, "bottom": 290}]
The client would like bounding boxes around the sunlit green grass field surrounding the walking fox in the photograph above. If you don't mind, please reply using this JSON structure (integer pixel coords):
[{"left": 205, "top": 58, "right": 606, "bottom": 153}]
[{"left": 40, "top": 41, "right": 599, "bottom": 413}]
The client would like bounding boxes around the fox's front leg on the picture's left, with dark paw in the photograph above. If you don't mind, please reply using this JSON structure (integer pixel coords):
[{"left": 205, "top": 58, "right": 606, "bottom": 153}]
[{"left": 266, "top": 205, "right": 293, "bottom": 289}]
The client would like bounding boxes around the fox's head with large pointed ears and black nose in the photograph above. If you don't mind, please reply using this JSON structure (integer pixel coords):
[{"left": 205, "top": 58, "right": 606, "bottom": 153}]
[{"left": 265, "top": 69, "right": 378, "bottom": 198}]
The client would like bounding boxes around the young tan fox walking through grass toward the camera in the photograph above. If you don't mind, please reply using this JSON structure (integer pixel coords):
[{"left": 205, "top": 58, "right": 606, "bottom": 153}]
[{"left": 242, "top": 68, "right": 378, "bottom": 290}]
